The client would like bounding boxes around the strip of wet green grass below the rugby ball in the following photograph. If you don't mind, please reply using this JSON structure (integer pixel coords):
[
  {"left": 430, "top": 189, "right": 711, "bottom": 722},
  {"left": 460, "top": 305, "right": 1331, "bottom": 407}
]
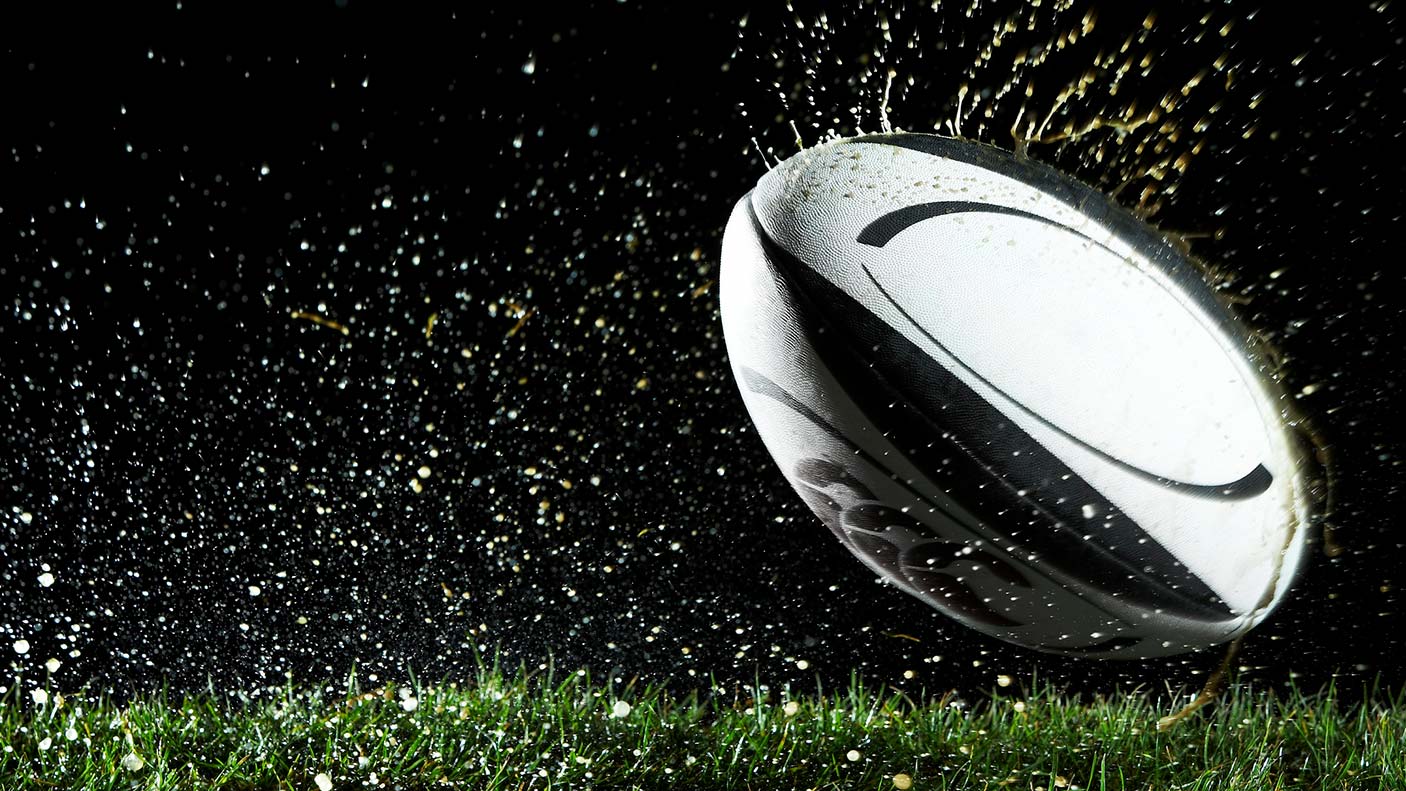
[{"left": 0, "top": 667, "right": 1406, "bottom": 791}]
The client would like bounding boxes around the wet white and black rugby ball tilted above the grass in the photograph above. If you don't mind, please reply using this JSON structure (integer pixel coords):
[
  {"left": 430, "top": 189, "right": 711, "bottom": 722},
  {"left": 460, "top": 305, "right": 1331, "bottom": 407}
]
[{"left": 720, "top": 133, "right": 1312, "bottom": 658}]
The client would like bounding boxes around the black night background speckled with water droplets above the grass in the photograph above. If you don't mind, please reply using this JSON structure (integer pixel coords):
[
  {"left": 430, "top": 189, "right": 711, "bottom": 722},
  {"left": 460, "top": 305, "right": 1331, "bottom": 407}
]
[{"left": 0, "top": 0, "right": 1406, "bottom": 702}]
